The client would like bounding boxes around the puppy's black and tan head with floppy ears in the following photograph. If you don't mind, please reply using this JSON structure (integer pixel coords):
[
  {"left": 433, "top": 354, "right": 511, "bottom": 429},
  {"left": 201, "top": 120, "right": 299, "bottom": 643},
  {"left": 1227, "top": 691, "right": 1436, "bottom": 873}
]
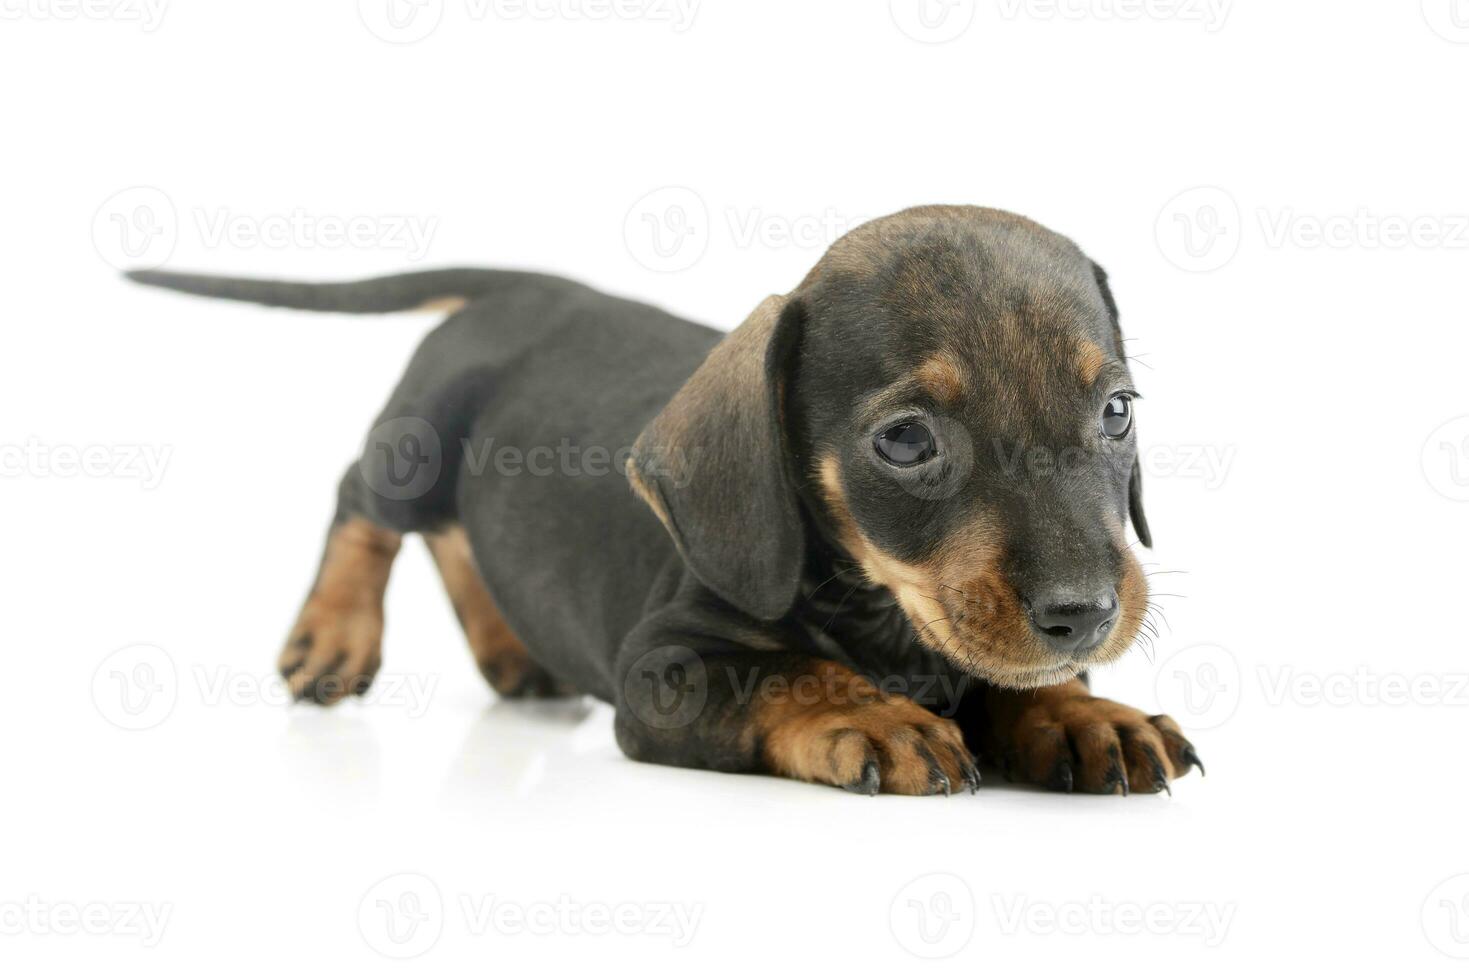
[{"left": 629, "top": 207, "right": 1152, "bottom": 688}]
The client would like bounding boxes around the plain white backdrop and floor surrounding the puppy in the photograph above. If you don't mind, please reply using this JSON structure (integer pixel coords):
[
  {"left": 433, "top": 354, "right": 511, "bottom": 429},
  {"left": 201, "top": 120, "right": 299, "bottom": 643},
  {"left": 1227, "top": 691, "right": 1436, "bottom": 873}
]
[{"left": 0, "top": 0, "right": 1469, "bottom": 977}]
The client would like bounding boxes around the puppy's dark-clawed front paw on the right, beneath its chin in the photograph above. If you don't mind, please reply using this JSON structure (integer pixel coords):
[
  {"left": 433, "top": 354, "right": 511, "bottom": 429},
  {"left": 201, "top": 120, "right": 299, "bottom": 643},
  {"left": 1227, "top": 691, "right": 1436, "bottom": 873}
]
[{"left": 997, "top": 685, "right": 1203, "bottom": 796}]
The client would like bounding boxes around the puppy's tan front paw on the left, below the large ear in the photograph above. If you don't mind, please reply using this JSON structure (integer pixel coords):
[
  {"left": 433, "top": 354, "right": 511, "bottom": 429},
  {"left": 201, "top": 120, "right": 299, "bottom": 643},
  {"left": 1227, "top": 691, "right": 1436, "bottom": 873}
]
[{"left": 759, "top": 666, "right": 980, "bottom": 796}]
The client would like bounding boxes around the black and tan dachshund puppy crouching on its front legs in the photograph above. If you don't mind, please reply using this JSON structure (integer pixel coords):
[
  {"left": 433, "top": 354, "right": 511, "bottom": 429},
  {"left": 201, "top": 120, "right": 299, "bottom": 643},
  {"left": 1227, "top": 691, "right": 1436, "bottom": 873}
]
[{"left": 132, "top": 207, "right": 1199, "bottom": 793}]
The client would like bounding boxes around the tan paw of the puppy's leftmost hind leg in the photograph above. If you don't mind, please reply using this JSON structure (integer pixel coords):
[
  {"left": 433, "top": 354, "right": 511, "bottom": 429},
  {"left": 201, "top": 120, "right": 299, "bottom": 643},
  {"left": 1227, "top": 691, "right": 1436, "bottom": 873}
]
[{"left": 278, "top": 597, "right": 382, "bottom": 704}]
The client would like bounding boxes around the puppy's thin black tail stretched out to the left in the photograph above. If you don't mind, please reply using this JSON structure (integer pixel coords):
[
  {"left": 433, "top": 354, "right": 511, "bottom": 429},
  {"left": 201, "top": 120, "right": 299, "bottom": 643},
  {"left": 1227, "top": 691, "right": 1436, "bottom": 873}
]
[{"left": 126, "top": 269, "right": 524, "bottom": 313}]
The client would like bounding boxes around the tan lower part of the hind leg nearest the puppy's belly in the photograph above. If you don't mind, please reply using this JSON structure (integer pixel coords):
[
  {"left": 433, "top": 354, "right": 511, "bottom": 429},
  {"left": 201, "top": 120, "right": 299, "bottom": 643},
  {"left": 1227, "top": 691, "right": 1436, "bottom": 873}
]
[{"left": 425, "top": 525, "right": 570, "bottom": 696}]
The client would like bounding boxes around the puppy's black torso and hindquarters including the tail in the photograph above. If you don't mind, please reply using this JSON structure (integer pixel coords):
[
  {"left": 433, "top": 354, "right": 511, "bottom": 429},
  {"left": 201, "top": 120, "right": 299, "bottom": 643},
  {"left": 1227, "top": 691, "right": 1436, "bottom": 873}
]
[{"left": 129, "top": 269, "right": 721, "bottom": 698}]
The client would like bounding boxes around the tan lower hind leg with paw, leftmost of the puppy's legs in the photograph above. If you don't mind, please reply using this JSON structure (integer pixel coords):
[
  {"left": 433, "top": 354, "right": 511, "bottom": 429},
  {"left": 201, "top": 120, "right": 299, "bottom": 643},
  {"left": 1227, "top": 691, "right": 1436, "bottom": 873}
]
[{"left": 278, "top": 517, "right": 403, "bottom": 704}]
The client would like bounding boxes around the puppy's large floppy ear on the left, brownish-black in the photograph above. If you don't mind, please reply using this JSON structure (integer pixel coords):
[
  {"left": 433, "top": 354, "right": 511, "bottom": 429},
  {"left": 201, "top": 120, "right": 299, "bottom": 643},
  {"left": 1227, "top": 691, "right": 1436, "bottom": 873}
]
[{"left": 627, "top": 295, "right": 805, "bottom": 620}]
